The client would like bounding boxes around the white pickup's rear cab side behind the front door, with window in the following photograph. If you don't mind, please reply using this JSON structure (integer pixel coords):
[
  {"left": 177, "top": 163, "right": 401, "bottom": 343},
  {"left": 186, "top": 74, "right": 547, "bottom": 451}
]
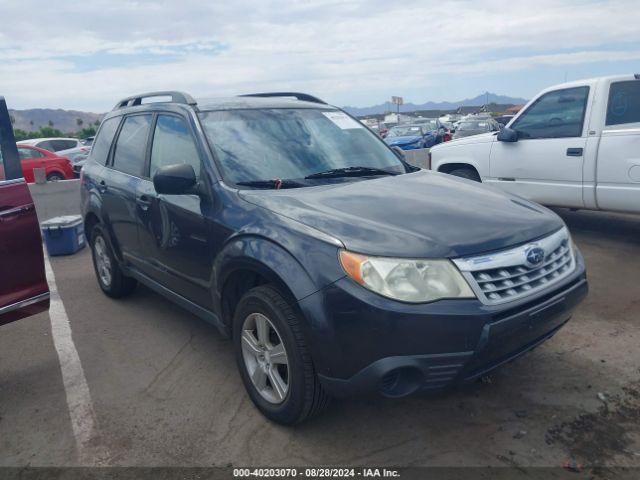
[{"left": 596, "top": 78, "right": 640, "bottom": 213}]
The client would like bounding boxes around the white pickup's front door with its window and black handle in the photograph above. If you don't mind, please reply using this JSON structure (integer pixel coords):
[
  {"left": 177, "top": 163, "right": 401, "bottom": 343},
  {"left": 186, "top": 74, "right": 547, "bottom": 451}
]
[{"left": 484, "top": 86, "right": 589, "bottom": 208}]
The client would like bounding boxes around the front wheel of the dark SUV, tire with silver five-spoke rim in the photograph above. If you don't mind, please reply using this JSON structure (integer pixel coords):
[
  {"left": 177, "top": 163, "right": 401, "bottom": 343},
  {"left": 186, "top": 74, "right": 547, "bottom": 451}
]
[{"left": 233, "top": 285, "right": 330, "bottom": 425}]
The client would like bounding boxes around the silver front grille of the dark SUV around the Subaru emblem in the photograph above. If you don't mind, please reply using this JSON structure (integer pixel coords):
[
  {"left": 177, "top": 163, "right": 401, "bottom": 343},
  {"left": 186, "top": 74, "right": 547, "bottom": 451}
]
[{"left": 454, "top": 228, "right": 575, "bottom": 305}]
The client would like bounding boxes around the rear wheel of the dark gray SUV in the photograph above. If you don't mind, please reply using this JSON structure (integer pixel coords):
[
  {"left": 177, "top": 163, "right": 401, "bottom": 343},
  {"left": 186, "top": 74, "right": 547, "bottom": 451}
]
[{"left": 91, "top": 225, "right": 138, "bottom": 298}]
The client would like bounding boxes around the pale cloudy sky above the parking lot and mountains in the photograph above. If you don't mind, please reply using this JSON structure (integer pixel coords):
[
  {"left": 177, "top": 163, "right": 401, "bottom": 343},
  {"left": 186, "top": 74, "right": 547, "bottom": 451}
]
[{"left": 0, "top": 0, "right": 640, "bottom": 112}]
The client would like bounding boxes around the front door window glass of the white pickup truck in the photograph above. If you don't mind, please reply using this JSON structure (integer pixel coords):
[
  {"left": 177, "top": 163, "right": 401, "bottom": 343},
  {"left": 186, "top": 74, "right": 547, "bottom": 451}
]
[{"left": 511, "top": 87, "right": 589, "bottom": 138}]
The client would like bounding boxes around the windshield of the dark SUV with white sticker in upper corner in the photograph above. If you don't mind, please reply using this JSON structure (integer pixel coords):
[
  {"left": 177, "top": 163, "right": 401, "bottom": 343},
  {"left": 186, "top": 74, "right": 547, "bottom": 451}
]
[{"left": 199, "top": 109, "right": 406, "bottom": 184}]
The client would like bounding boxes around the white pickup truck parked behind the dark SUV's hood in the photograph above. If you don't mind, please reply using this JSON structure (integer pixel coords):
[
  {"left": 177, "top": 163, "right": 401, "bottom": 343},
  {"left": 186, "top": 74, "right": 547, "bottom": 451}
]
[{"left": 431, "top": 74, "right": 640, "bottom": 213}]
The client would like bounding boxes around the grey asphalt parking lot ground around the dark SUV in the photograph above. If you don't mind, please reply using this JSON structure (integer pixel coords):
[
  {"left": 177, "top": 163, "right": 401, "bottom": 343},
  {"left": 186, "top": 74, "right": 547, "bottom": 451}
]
[{"left": 0, "top": 210, "right": 640, "bottom": 466}]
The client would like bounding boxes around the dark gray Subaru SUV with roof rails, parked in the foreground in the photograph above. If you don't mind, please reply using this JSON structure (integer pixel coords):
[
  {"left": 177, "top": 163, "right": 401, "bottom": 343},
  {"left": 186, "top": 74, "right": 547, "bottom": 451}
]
[{"left": 82, "top": 92, "right": 587, "bottom": 424}]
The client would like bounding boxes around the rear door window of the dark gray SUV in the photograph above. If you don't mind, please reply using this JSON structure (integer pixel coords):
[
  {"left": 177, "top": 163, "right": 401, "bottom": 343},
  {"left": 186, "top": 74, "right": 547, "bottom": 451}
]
[{"left": 113, "top": 115, "right": 151, "bottom": 177}]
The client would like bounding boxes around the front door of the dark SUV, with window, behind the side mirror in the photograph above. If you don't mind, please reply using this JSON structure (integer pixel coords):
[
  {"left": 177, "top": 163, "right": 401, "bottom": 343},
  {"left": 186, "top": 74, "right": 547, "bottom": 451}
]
[{"left": 137, "top": 113, "right": 215, "bottom": 308}]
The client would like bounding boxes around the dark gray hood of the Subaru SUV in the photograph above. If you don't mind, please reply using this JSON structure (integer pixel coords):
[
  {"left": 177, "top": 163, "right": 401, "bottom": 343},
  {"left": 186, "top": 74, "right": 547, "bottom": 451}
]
[{"left": 240, "top": 170, "right": 563, "bottom": 258}]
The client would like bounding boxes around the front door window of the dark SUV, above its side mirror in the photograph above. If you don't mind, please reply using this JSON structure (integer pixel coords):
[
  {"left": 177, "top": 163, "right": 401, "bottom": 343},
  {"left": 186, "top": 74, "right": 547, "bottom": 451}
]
[{"left": 149, "top": 115, "right": 200, "bottom": 178}]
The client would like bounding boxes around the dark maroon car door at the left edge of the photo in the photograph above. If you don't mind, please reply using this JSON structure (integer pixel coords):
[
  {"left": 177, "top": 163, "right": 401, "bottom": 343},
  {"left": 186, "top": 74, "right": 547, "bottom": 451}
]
[{"left": 0, "top": 97, "right": 49, "bottom": 325}]
